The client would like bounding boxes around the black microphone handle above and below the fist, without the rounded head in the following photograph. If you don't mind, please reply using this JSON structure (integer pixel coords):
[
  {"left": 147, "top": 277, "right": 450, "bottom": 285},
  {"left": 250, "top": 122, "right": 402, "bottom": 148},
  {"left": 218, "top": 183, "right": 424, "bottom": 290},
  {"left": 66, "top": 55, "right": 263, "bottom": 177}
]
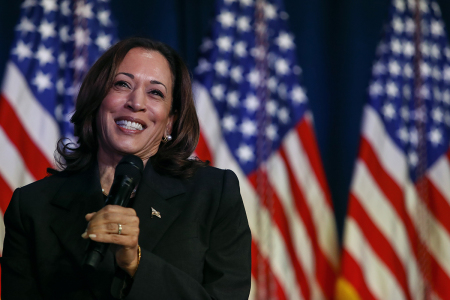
[{"left": 83, "top": 175, "right": 136, "bottom": 270}]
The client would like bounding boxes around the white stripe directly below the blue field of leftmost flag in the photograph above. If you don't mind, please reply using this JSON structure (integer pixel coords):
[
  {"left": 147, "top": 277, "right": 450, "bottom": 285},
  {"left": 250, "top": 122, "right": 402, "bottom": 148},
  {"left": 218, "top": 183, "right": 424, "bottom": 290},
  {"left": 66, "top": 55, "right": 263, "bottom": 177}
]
[{"left": 2, "top": 62, "right": 60, "bottom": 162}]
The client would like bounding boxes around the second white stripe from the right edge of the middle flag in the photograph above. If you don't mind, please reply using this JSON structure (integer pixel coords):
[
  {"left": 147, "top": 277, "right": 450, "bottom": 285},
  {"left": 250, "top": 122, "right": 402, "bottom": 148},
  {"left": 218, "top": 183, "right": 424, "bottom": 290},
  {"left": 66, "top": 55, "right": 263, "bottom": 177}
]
[{"left": 267, "top": 154, "right": 325, "bottom": 300}]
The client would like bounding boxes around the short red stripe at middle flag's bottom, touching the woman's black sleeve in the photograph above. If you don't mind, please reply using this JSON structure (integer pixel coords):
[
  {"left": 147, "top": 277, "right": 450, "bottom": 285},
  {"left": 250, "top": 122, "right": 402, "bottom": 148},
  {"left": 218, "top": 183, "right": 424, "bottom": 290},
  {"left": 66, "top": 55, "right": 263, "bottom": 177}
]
[{"left": 252, "top": 240, "right": 287, "bottom": 300}]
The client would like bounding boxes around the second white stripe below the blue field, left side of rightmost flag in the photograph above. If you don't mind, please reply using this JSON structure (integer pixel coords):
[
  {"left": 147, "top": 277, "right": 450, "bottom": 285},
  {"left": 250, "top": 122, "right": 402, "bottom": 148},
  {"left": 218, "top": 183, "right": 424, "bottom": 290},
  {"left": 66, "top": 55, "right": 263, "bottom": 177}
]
[{"left": 351, "top": 159, "right": 421, "bottom": 299}]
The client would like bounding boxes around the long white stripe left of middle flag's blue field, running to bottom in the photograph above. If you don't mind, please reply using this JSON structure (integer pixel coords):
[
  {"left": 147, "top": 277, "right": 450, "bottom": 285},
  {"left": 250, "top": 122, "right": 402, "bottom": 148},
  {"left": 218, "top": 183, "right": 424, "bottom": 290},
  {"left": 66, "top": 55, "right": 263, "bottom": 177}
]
[{"left": 194, "top": 83, "right": 301, "bottom": 299}]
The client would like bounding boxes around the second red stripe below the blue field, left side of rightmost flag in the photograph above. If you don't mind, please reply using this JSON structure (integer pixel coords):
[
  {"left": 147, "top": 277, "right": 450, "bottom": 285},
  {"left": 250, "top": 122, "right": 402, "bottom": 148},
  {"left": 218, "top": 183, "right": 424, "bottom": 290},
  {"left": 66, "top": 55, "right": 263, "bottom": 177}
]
[{"left": 348, "top": 194, "right": 411, "bottom": 299}]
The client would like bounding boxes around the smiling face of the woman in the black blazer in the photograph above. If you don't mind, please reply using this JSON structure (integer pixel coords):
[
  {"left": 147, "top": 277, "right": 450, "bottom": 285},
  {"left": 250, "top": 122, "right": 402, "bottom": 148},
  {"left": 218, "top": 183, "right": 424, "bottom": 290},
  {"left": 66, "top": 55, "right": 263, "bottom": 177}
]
[{"left": 97, "top": 48, "right": 173, "bottom": 161}]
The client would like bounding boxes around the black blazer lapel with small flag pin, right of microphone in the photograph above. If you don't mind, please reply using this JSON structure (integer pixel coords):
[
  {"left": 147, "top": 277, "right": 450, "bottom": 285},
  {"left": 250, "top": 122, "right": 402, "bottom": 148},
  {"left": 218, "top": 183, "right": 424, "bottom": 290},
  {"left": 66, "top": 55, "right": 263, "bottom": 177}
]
[{"left": 133, "top": 161, "right": 186, "bottom": 251}]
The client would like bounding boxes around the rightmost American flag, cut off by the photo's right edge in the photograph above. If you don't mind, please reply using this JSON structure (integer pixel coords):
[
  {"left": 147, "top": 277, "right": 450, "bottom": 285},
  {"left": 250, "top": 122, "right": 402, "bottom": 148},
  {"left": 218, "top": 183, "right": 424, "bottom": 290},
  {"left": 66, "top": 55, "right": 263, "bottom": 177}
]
[{"left": 337, "top": 0, "right": 450, "bottom": 300}]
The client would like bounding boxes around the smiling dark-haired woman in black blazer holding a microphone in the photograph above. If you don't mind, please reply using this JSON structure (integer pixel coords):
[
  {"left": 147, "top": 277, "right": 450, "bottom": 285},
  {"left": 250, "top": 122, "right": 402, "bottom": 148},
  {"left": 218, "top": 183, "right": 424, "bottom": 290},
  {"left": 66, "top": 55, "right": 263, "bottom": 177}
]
[{"left": 2, "top": 38, "right": 251, "bottom": 300}]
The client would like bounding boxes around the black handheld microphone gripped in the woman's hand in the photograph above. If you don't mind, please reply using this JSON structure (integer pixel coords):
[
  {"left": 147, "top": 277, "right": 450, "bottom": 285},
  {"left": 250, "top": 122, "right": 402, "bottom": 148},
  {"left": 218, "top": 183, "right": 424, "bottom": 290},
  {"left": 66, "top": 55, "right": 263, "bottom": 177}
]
[{"left": 83, "top": 154, "right": 144, "bottom": 270}]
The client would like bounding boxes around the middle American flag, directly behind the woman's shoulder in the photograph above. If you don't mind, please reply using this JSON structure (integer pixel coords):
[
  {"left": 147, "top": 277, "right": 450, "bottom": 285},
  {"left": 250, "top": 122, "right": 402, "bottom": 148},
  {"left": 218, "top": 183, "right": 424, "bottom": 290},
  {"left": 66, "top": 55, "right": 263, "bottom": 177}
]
[{"left": 194, "top": 0, "right": 338, "bottom": 299}]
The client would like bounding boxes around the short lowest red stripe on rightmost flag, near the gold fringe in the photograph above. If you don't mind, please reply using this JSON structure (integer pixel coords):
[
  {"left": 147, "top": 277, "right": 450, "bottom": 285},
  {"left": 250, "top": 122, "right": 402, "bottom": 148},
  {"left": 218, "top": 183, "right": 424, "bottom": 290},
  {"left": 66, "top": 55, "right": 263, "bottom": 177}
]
[{"left": 342, "top": 249, "right": 381, "bottom": 300}]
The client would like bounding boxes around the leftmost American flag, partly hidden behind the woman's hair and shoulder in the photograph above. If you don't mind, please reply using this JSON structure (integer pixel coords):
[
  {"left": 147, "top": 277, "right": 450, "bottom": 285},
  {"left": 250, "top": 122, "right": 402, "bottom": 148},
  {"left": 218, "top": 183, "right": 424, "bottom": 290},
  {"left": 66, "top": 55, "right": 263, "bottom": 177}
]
[{"left": 0, "top": 0, "right": 116, "bottom": 255}]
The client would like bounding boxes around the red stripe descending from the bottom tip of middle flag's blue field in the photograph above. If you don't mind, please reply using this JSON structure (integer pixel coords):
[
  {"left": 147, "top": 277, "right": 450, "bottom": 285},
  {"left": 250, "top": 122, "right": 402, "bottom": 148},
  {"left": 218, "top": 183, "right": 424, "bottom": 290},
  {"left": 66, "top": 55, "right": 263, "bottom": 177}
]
[{"left": 248, "top": 170, "right": 311, "bottom": 299}]
